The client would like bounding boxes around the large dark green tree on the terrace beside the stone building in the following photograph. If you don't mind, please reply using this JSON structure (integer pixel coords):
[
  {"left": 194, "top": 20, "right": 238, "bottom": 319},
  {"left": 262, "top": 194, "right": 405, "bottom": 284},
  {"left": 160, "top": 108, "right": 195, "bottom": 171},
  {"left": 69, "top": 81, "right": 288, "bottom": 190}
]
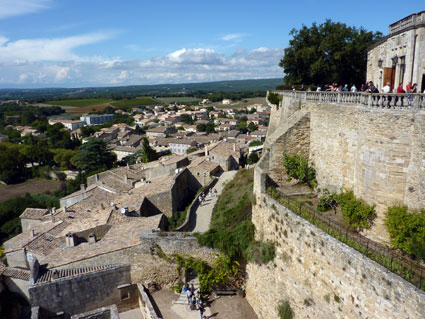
[{"left": 279, "top": 20, "right": 382, "bottom": 85}]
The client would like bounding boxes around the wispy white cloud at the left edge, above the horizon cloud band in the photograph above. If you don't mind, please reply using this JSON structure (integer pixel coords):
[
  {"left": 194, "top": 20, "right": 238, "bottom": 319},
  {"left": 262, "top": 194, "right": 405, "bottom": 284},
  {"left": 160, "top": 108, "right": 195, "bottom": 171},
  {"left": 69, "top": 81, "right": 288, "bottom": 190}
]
[{"left": 0, "top": 33, "right": 109, "bottom": 62}]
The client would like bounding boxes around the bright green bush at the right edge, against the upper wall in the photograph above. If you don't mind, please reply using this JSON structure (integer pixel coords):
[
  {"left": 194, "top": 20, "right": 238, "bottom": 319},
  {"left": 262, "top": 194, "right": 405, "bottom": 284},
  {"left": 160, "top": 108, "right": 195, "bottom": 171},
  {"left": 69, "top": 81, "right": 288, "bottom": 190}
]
[{"left": 385, "top": 206, "right": 425, "bottom": 259}]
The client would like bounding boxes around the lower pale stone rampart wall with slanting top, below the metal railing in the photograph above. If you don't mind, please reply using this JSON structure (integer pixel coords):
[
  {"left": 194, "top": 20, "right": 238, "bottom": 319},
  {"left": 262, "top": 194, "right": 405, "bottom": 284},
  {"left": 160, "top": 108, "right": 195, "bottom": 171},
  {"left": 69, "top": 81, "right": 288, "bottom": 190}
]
[{"left": 246, "top": 154, "right": 425, "bottom": 319}]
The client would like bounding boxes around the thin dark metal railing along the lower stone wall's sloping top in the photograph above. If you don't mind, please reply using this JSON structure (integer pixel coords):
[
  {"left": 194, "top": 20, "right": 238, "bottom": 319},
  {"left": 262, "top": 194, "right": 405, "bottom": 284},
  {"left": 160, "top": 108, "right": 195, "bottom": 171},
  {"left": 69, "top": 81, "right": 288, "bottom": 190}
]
[{"left": 266, "top": 186, "right": 425, "bottom": 291}]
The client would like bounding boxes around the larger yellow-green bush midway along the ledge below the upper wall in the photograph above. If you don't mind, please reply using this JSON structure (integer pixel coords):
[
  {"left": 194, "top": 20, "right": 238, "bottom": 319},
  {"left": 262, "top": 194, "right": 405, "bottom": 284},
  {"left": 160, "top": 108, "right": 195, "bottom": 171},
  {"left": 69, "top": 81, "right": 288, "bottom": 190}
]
[{"left": 336, "top": 191, "right": 376, "bottom": 231}]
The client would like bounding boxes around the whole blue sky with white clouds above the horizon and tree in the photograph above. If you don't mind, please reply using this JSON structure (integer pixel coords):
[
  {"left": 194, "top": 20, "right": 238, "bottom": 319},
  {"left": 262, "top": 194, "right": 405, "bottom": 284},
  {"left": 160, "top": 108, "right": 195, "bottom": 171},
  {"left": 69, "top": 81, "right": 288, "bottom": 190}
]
[{"left": 0, "top": 0, "right": 425, "bottom": 88}]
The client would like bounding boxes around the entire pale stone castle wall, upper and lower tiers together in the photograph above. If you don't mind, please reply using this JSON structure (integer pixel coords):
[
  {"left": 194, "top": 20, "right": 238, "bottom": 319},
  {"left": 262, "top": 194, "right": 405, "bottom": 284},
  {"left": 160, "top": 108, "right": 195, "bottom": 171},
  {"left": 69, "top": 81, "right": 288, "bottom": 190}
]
[{"left": 246, "top": 98, "right": 425, "bottom": 319}]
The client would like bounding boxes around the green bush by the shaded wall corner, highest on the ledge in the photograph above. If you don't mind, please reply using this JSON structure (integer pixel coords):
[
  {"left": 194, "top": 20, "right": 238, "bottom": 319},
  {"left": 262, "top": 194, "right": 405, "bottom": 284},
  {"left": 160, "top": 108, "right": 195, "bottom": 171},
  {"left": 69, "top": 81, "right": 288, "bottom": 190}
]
[{"left": 283, "top": 153, "right": 317, "bottom": 188}]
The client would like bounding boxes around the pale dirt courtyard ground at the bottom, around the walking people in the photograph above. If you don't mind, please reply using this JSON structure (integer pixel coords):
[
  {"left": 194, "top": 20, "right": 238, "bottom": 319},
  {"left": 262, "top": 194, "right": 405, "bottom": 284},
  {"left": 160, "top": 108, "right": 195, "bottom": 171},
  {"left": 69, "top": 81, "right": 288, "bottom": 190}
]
[{"left": 152, "top": 289, "right": 258, "bottom": 319}]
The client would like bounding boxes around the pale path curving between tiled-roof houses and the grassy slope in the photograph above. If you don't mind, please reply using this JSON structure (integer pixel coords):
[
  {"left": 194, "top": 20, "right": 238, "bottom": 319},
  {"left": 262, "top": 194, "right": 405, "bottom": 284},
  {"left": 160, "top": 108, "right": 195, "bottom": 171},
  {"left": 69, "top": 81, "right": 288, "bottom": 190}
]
[{"left": 190, "top": 171, "right": 237, "bottom": 233}]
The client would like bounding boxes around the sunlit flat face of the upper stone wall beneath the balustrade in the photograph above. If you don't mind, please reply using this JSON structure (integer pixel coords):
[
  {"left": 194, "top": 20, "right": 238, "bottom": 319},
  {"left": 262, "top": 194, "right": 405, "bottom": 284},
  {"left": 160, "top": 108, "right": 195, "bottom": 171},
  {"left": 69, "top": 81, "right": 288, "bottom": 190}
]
[{"left": 310, "top": 104, "right": 425, "bottom": 241}]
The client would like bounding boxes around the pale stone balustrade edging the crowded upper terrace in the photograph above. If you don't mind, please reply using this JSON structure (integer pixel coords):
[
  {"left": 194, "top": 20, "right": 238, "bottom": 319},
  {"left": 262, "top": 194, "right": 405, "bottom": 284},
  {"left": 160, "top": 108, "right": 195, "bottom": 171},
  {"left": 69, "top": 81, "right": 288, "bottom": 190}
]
[{"left": 273, "top": 91, "right": 425, "bottom": 109}]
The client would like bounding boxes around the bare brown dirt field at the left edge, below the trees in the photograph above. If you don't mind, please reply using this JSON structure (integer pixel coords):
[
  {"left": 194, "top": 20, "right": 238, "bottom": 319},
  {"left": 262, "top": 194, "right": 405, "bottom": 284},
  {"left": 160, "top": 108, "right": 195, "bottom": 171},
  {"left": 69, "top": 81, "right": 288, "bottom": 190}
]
[{"left": 0, "top": 179, "right": 61, "bottom": 202}]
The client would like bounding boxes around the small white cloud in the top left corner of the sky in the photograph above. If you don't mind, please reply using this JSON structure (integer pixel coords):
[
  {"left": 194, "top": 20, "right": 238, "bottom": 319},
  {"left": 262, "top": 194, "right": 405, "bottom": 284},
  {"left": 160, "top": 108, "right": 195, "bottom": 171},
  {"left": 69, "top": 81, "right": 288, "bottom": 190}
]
[{"left": 0, "top": 0, "right": 52, "bottom": 19}]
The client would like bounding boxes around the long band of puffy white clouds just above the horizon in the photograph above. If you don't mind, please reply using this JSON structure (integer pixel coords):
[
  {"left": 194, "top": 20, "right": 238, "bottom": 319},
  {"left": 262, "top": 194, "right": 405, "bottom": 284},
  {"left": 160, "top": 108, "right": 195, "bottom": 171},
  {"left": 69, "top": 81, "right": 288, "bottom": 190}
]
[{"left": 0, "top": 48, "right": 283, "bottom": 87}]
